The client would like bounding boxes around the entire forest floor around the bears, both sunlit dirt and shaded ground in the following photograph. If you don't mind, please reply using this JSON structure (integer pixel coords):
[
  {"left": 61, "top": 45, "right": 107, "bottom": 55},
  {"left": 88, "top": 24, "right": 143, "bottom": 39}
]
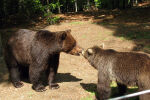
[{"left": 0, "top": 5, "right": 150, "bottom": 100}]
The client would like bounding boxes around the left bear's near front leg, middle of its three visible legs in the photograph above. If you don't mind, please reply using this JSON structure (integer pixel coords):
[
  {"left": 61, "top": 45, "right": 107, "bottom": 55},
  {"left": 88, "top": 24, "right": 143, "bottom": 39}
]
[{"left": 29, "top": 62, "right": 46, "bottom": 92}]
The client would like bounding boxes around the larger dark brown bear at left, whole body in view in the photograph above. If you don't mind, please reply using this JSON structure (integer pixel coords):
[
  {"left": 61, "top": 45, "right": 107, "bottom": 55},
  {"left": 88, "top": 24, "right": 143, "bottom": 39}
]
[{"left": 4, "top": 29, "right": 81, "bottom": 92}]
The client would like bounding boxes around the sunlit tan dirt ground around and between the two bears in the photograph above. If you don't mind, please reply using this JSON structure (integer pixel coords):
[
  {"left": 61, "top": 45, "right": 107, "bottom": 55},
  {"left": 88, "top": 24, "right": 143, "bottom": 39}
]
[{"left": 0, "top": 6, "right": 150, "bottom": 100}]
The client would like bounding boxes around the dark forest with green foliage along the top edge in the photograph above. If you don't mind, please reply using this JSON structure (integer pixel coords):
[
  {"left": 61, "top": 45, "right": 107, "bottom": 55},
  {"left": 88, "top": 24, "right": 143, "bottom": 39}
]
[{"left": 0, "top": 0, "right": 145, "bottom": 25}]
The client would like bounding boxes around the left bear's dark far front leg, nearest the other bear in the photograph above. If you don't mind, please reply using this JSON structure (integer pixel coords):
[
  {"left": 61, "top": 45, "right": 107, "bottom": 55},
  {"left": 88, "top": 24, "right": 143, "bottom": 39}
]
[{"left": 48, "top": 54, "right": 60, "bottom": 89}]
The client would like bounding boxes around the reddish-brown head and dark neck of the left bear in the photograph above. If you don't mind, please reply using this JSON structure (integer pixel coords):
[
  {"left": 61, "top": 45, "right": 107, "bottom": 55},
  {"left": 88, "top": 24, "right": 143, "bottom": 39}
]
[{"left": 36, "top": 30, "right": 82, "bottom": 55}]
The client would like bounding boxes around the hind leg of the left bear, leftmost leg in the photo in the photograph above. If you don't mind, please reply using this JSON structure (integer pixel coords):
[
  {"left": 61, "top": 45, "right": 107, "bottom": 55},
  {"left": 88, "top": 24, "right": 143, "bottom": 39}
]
[{"left": 5, "top": 53, "right": 23, "bottom": 88}]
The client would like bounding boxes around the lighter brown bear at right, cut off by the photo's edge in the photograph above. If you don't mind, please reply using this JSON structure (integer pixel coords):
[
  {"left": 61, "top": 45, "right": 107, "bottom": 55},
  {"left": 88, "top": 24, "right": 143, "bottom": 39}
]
[{"left": 82, "top": 46, "right": 150, "bottom": 100}]
